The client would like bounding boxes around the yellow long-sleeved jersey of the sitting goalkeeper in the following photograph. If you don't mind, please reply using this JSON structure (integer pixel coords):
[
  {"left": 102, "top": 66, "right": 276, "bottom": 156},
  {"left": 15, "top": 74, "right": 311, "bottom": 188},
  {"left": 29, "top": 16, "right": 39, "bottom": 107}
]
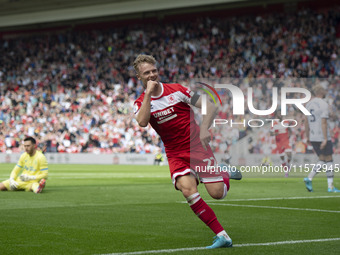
[{"left": 10, "top": 151, "right": 48, "bottom": 180}]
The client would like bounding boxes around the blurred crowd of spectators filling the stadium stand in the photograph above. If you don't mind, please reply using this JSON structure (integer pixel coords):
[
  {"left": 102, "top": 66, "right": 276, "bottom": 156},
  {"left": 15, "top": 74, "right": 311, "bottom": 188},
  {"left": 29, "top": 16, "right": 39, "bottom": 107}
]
[{"left": 0, "top": 7, "right": 340, "bottom": 153}]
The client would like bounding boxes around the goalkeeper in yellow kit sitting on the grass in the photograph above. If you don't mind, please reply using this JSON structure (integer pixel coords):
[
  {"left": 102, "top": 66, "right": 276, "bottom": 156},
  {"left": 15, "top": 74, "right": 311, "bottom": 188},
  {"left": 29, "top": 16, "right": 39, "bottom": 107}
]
[{"left": 0, "top": 137, "right": 48, "bottom": 193}]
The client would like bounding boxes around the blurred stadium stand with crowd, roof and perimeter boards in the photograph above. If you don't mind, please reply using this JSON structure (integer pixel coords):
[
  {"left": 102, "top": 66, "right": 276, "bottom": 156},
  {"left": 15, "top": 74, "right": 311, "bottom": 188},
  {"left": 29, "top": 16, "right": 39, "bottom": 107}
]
[{"left": 0, "top": 0, "right": 340, "bottom": 164}]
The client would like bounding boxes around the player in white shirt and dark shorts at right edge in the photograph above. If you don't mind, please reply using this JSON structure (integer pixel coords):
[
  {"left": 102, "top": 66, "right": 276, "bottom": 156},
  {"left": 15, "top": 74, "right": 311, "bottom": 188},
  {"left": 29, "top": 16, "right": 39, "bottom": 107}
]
[{"left": 304, "top": 85, "right": 340, "bottom": 192}]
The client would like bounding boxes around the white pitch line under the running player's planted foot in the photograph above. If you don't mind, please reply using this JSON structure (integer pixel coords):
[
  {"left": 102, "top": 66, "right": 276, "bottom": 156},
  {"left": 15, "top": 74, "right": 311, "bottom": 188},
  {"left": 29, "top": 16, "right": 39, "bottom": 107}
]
[{"left": 102, "top": 238, "right": 340, "bottom": 255}]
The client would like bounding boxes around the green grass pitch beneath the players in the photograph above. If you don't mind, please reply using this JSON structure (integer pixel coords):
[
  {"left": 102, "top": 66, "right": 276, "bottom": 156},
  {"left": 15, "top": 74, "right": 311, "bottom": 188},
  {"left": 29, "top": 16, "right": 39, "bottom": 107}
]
[{"left": 0, "top": 164, "right": 340, "bottom": 255}]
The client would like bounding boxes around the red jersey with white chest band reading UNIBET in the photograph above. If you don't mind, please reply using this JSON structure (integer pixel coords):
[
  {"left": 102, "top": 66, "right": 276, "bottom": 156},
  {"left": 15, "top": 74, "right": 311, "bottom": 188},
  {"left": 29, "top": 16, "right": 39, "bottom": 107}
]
[{"left": 134, "top": 83, "right": 201, "bottom": 156}]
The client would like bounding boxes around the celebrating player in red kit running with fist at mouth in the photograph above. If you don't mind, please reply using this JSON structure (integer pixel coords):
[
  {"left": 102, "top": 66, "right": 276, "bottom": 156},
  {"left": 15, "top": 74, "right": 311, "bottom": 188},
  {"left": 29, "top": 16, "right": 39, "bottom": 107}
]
[{"left": 134, "top": 55, "right": 232, "bottom": 249}]
